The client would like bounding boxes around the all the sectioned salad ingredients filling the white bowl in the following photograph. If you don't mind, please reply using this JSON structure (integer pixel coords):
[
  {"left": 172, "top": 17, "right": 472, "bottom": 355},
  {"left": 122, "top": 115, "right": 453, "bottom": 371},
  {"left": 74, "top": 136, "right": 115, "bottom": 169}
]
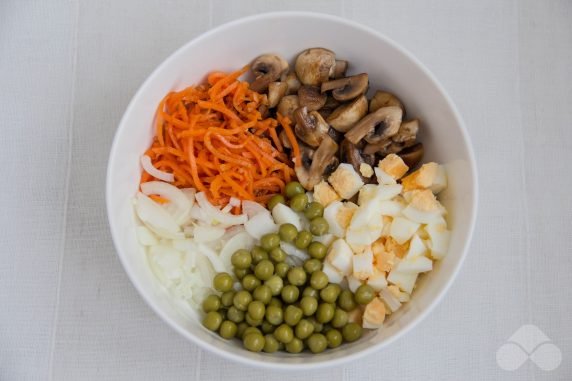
[{"left": 135, "top": 48, "right": 449, "bottom": 353}]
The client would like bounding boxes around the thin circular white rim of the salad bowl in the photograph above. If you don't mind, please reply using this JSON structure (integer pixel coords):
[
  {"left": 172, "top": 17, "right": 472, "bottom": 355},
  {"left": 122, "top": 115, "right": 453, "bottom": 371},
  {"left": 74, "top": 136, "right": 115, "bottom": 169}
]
[{"left": 105, "top": 11, "right": 479, "bottom": 371}]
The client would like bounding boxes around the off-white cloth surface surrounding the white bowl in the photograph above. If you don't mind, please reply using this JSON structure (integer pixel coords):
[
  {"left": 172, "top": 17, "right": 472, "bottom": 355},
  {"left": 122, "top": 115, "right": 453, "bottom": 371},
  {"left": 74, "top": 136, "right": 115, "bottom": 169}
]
[{"left": 0, "top": 0, "right": 572, "bottom": 381}]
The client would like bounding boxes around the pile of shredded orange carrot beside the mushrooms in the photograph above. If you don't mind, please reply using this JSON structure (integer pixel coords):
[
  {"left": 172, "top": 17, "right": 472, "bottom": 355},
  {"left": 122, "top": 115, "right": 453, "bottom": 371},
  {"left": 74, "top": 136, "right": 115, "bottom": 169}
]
[{"left": 140, "top": 67, "right": 294, "bottom": 206}]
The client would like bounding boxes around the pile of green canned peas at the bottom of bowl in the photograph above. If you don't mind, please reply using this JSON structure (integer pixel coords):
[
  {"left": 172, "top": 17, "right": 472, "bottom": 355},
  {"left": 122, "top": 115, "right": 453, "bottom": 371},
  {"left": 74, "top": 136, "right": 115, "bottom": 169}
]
[{"left": 202, "top": 182, "right": 375, "bottom": 353}]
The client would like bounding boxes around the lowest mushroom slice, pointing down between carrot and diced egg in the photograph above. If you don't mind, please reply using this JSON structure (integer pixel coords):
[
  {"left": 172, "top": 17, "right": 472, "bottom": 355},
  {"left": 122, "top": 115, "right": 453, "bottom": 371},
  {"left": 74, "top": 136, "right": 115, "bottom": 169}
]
[{"left": 295, "top": 136, "right": 338, "bottom": 190}]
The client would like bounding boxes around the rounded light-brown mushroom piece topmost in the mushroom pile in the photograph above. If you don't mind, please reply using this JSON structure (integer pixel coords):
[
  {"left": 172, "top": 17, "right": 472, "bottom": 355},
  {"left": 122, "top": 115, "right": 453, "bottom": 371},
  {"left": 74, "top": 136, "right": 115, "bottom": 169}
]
[{"left": 294, "top": 48, "right": 336, "bottom": 86}]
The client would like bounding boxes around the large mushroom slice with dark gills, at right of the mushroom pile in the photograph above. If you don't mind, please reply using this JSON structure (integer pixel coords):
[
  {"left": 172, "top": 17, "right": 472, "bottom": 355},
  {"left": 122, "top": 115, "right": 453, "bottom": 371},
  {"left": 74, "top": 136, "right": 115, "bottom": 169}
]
[{"left": 346, "top": 106, "right": 403, "bottom": 144}]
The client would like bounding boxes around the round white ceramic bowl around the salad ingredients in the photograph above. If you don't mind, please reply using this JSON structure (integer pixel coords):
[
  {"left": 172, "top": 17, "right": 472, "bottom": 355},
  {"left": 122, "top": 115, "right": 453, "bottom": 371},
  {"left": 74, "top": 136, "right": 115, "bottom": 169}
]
[{"left": 107, "top": 12, "right": 477, "bottom": 369}]
